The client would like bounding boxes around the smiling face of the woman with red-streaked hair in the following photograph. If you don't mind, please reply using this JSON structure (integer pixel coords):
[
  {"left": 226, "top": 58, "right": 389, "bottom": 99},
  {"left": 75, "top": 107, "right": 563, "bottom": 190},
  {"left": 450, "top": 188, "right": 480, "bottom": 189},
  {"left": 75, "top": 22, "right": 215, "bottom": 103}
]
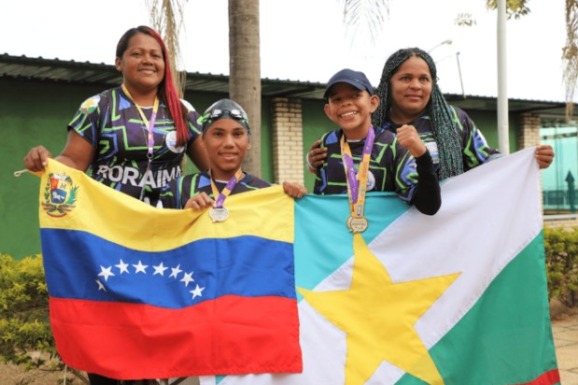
[{"left": 115, "top": 32, "right": 165, "bottom": 100}]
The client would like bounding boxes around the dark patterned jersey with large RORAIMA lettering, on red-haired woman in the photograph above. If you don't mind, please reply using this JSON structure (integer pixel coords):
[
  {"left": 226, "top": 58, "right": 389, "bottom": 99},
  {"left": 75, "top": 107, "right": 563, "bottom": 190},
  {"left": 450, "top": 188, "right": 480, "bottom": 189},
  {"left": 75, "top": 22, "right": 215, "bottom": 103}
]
[{"left": 68, "top": 87, "right": 201, "bottom": 206}]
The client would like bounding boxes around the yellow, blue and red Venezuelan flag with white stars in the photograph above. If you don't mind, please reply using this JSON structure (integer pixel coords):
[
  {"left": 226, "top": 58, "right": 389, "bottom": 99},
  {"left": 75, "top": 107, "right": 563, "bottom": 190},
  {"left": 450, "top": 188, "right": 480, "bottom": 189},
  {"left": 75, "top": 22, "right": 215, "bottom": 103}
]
[{"left": 39, "top": 160, "right": 302, "bottom": 379}]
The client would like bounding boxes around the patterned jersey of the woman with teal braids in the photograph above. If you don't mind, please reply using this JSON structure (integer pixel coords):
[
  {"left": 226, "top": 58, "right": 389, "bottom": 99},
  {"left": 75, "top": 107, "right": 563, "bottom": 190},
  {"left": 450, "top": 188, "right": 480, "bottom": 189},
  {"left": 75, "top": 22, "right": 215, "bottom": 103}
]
[{"left": 382, "top": 106, "right": 500, "bottom": 172}]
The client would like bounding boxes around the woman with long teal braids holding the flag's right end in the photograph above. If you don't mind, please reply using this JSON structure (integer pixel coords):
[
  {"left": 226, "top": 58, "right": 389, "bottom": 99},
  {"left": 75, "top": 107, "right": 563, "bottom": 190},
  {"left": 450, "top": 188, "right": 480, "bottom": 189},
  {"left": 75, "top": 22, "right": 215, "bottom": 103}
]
[{"left": 307, "top": 48, "right": 554, "bottom": 180}]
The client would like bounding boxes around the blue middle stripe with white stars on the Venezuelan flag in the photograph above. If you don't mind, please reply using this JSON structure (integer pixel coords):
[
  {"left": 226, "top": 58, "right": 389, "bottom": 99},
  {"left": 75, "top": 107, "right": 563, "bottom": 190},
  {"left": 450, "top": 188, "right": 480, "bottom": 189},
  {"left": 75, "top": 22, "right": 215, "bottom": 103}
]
[{"left": 41, "top": 229, "right": 295, "bottom": 308}]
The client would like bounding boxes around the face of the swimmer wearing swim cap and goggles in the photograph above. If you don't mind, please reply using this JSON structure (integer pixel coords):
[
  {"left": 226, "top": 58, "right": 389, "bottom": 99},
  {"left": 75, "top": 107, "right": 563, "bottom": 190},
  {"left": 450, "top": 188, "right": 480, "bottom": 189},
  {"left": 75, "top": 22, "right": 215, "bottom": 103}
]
[{"left": 203, "top": 119, "right": 251, "bottom": 181}]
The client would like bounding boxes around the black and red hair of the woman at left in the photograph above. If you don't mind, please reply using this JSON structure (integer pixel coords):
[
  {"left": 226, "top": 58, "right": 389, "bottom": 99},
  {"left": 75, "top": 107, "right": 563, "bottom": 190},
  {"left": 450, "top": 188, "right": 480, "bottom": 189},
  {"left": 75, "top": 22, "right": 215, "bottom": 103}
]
[{"left": 116, "top": 25, "right": 189, "bottom": 146}]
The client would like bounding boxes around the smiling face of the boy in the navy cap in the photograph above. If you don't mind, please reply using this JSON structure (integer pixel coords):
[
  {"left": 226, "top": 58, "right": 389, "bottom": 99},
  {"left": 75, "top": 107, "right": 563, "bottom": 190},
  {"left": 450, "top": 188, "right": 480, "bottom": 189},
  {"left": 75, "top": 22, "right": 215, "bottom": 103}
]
[{"left": 324, "top": 83, "right": 379, "bottom": 139}]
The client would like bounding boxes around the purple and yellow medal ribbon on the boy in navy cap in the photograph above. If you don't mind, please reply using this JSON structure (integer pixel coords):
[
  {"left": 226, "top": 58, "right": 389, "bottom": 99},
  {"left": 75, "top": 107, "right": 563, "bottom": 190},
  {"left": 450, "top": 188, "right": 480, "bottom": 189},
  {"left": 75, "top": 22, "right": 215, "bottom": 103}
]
[{"left": 340, "top": 127, "right": 375, "bottom": 218}]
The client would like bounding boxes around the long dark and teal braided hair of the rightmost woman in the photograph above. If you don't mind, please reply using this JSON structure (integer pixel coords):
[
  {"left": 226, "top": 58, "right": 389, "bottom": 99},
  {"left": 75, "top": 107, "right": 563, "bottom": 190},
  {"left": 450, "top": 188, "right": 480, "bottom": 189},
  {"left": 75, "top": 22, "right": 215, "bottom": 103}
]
[{"left": 372, "top": 48, "right": 464, "bottom": 179}]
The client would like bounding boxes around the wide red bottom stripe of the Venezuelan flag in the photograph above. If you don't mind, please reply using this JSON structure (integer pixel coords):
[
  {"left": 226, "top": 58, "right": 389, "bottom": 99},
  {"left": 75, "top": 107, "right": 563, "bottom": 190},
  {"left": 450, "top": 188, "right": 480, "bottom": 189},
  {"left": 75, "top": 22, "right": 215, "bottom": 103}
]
[{"left": 50, "top": 296, "right": 302, "bottom": 379}]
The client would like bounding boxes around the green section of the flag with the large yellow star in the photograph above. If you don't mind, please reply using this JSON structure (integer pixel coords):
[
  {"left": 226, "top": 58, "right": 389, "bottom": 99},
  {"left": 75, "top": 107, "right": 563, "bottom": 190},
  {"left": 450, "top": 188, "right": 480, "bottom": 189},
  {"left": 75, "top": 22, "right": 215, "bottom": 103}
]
[{"left": 398, "top": 233, "right": 557, "bottom": 385}]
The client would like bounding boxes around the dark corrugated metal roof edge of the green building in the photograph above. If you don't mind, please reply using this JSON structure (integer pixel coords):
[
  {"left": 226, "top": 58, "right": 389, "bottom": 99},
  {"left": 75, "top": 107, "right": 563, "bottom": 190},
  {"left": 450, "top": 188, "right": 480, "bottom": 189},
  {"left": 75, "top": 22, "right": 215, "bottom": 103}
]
[{"left": 0, "top": 53, "right": 578, "bottom": 115}]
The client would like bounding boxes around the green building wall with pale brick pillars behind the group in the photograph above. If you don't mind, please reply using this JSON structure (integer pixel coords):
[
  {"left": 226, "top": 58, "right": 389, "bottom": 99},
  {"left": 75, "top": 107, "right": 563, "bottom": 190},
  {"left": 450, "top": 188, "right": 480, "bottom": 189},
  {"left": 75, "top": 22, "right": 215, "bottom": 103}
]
[{"left": 0, "top": 79, "right": 576, "bottom": 258}]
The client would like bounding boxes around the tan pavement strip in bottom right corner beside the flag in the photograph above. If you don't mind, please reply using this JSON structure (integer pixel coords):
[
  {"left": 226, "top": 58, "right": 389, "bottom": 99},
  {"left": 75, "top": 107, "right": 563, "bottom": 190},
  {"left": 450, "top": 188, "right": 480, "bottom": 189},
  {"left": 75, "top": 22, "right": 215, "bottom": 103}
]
[{"left": 552, "top": 313, "right": 578, "bottom": 385}]
